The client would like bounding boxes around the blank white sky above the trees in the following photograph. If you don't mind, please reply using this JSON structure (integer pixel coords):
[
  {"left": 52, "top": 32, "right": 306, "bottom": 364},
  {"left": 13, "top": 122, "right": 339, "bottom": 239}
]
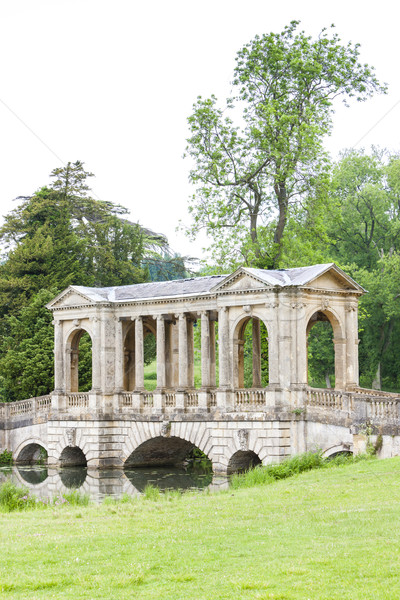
[{"left": 0, "top": 0, "right": 400, "bottom": 258}]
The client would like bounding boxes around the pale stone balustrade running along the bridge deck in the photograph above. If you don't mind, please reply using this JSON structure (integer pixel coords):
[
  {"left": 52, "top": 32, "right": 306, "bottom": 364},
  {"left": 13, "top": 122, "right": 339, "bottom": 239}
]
[{"left": 0, "top": 388, "right": 400, "bottom": 428}]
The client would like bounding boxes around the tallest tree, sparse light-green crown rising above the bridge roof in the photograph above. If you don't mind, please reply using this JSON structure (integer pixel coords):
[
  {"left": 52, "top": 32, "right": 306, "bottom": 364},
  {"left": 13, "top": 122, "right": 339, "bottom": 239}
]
[{"left": 186, "top": 21, "right": 386, "bottom": 268}]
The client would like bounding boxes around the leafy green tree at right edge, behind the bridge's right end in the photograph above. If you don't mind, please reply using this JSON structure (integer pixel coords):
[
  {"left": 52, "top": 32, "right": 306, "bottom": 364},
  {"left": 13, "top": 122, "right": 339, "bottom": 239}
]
[{"left": 325, "top": 148, "right": 400, "bottom": 389}]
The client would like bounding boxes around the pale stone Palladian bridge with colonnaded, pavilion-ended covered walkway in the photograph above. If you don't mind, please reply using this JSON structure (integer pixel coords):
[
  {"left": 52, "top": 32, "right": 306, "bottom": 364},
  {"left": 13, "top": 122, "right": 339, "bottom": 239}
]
[{"left": 0, "top": 263, "right": 400, "bottom": 473}]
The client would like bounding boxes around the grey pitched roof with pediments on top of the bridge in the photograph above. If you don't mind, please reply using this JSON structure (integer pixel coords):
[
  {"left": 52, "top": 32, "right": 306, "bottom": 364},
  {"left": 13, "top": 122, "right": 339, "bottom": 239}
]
[{"left": 47, "top": 263, "right": 365, "bottom": 308}]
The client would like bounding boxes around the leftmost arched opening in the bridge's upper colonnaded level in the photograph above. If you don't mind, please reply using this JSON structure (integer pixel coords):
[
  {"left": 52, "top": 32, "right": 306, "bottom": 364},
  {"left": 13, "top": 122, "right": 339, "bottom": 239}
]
[{"left": 70, "top": 329, "right": 92, "bottom": 392}]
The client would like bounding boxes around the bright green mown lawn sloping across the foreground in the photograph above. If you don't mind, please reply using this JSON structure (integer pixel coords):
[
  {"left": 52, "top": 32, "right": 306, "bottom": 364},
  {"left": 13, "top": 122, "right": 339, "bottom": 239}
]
[{"left": 0, "top": 458, "right": 400, "bottom": 600}]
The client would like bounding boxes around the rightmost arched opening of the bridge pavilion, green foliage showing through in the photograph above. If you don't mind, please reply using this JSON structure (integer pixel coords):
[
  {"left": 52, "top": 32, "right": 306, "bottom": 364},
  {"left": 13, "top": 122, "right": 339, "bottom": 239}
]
[{"left": 307, "top": 311, "right": 342, "bottom": 388}]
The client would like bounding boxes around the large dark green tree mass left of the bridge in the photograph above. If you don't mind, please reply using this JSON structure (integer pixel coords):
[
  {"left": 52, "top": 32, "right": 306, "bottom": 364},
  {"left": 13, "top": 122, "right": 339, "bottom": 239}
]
[{"left": 0, "top": 161, "right": 152, "bottom": 401}]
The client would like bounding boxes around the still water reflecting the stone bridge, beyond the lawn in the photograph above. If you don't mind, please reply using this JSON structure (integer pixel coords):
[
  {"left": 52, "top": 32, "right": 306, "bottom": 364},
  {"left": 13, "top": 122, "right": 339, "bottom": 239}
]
[{"left": 0, "top": 466, "right": 228, "bottom": 502}]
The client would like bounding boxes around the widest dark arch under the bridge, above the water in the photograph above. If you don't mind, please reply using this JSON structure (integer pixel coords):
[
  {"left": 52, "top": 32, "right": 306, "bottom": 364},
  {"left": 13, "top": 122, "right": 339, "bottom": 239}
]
[{"left": 124, "top": 436, "right": 212, "bottom": 492}]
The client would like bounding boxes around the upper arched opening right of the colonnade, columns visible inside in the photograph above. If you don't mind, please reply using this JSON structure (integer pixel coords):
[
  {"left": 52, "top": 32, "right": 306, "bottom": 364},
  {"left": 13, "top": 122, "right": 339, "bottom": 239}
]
[{"left": 235, "top": 317, "right": 269, "bottom": 388}]
